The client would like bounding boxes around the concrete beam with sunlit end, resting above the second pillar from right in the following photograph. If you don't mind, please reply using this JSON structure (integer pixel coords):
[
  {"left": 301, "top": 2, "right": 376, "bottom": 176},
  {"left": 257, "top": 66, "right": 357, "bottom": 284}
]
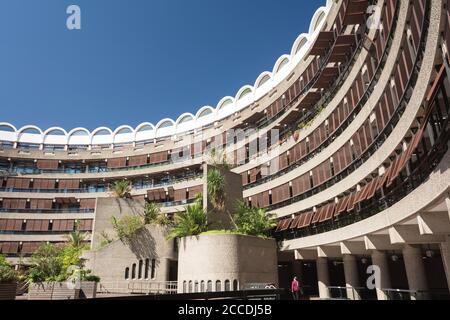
[{"left": 389, "top": 226, "right": 445, "bottom": 244}]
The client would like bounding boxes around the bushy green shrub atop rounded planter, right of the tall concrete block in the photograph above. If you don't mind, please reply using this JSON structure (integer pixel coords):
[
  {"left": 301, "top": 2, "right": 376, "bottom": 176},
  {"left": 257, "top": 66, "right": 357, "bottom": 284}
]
[{"left": 234, "top": 201, "right": 276, "bottom": 237}]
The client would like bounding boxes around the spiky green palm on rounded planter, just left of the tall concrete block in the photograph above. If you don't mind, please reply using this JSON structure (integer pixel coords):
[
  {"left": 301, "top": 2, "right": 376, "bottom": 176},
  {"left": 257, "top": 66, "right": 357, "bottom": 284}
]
[{"left": 168, "top": 202, "right": 208, "bottom": 239}]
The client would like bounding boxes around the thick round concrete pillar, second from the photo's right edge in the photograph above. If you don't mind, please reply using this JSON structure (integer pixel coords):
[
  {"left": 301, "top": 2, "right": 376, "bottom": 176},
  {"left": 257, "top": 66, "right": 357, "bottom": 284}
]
[{"left": 403, "top": 244, "right": 428, "bottom": 300}]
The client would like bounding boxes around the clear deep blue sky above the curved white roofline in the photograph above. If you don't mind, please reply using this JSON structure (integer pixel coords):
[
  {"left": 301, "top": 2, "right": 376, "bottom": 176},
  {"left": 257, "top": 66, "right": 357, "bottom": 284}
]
[{"left": 0, "top": 0, "right": 325, "bottom": 129}]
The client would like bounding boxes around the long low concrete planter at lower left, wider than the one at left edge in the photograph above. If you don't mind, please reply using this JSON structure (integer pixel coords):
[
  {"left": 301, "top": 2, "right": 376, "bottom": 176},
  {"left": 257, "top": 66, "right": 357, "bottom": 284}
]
[{"left": 28, "top": 282, "right": 97, "bottom": 300}]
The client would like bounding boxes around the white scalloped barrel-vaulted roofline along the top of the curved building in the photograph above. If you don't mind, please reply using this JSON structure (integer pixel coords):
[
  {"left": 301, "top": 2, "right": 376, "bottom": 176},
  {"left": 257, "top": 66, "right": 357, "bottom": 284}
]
[{"left": 0, "top": 0, "right": 333, "bottom": 145}]
